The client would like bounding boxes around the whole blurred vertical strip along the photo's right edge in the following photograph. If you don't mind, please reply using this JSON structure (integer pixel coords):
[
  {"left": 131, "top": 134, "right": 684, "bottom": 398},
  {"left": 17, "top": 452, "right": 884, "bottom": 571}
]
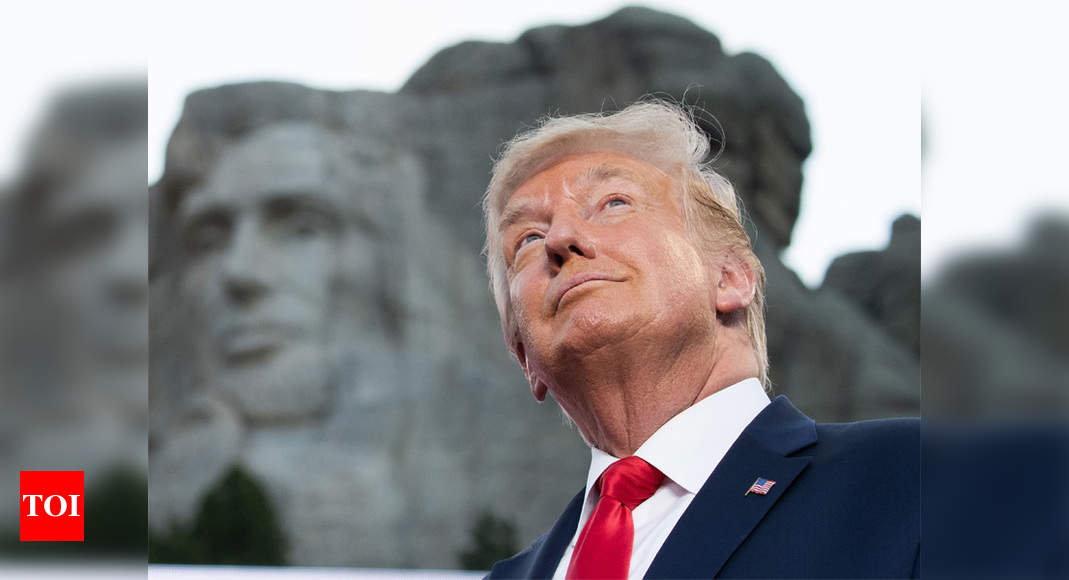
[{"left": 920, "top": 2, "right": 1069, "bottom": 578}]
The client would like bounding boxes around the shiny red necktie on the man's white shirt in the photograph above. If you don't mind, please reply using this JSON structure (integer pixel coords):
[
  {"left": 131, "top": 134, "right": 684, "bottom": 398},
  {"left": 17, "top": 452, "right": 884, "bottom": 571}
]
[{"left": 566, "top": 455, "right": 665, "bottom": 580}]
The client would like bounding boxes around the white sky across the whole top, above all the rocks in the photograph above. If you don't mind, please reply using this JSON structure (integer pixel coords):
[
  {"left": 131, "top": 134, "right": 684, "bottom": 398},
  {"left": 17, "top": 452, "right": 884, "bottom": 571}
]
[{"left": 0, "top": 0, "right": 1067, "bottom": 285}]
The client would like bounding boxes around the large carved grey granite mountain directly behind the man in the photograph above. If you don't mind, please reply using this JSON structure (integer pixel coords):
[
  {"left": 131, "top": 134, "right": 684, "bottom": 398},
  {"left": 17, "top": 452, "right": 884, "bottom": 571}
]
[{"left": 150, "top": 9, "right": 919, "bottom": 568}]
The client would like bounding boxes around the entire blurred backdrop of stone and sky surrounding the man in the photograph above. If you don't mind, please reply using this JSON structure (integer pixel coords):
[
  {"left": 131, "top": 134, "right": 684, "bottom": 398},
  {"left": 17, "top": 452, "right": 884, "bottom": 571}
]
[{"left": 0, "top": 1, "right": 1069, "bottom": 576}]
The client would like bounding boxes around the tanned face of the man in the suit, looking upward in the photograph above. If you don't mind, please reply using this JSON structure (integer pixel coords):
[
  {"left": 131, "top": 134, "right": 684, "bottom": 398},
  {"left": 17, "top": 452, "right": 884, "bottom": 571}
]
[{"left": 500, "top": 153, "right": 716, "bottom": 399}]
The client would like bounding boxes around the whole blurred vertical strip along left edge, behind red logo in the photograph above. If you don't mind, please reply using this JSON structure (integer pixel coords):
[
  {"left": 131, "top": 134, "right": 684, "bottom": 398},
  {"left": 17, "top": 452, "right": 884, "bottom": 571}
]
[{"left": 0, "top": 2, "right": 149, "bottom": 577}]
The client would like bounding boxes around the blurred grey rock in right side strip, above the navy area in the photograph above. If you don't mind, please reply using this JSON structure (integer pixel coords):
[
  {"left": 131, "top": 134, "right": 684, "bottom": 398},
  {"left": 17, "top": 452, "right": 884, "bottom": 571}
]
[{"left": 920, "top": 216, "right": 1069, "bottom": 421}]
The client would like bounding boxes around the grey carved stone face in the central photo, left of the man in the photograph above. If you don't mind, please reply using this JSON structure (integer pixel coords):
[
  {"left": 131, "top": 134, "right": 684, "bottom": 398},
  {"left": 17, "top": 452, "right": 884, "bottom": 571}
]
[{"left": 177, "top": 124, "right": 410, "bottom": 421}]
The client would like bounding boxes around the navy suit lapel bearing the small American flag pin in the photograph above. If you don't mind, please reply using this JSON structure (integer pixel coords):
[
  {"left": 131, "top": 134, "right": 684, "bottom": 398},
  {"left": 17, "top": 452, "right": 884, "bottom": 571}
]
[{"left": 641, "top": 395, "right": 817, "bottom": 578}]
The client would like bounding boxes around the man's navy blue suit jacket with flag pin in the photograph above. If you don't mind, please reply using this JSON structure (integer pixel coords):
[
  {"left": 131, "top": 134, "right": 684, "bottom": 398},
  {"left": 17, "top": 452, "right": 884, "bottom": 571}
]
[{"left": 489, "top": 395, "right": 920, "bottom": 578}]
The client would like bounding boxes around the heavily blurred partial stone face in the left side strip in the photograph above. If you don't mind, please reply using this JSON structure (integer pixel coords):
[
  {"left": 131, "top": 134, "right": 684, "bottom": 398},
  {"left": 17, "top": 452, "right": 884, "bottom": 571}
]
[{"left": 41, "top": 139, "right": 149, "bottom": 419}]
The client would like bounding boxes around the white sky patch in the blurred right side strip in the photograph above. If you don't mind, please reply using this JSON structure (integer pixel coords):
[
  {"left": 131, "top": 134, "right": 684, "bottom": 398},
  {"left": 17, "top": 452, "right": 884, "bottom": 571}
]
[{"left": 921, "top": 1, "right": 1069, "bottom": 276}]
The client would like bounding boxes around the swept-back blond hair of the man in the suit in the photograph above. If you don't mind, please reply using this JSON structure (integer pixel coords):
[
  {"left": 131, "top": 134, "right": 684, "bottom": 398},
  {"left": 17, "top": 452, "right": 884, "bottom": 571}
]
[{"left": 482, "top": 100, "right": 769, "bottom": 386}]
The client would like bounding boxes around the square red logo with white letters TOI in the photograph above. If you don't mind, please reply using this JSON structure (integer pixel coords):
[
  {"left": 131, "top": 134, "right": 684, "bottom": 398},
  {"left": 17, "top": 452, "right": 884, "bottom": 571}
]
[{"left": 18, "top": 471, "right": 86, "bottom": 542}]
